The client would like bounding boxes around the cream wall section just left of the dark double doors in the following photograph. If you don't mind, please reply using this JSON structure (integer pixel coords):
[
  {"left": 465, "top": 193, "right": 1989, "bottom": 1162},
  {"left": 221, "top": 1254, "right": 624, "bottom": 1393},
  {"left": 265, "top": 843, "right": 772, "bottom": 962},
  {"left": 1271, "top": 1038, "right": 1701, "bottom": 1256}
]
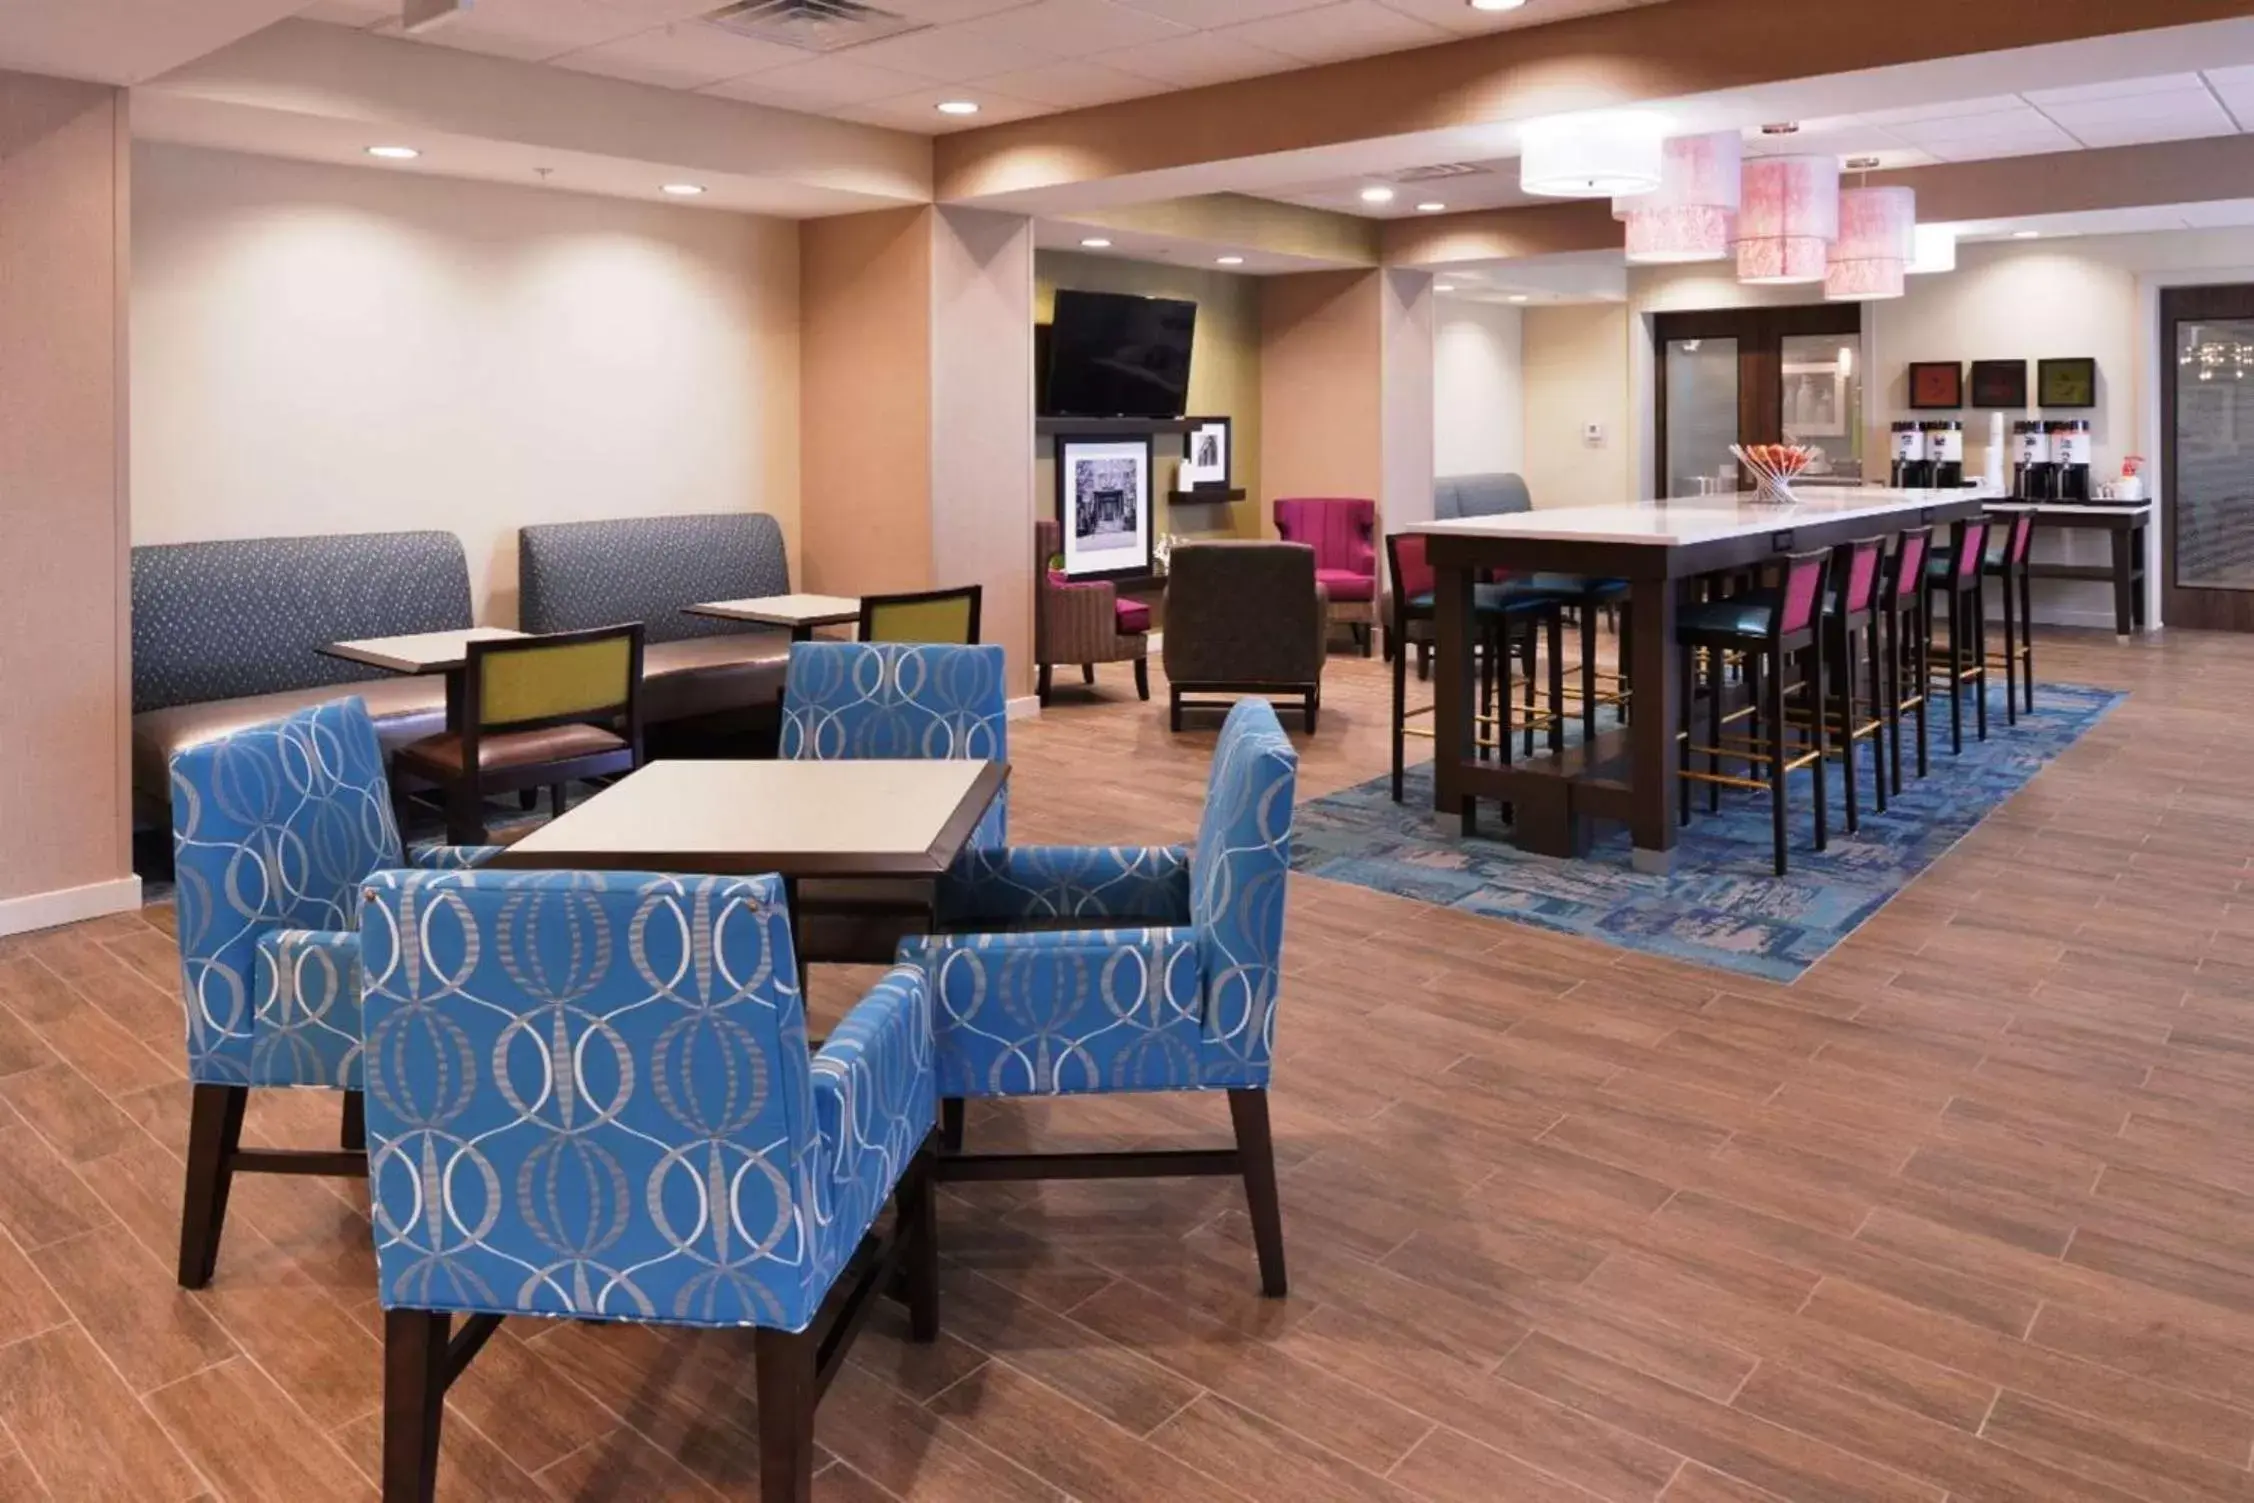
[{"left": 1519, "top": 302, "right": 1643, "bottom": 507}]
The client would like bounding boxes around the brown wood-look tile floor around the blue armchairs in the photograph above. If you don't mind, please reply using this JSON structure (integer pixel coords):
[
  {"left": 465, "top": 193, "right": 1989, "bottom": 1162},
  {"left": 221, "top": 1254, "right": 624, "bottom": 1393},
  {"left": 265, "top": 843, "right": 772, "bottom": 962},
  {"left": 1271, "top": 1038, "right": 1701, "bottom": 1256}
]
[{"left": 0, "top": 633, "right": 2254, "bottom": 1503}]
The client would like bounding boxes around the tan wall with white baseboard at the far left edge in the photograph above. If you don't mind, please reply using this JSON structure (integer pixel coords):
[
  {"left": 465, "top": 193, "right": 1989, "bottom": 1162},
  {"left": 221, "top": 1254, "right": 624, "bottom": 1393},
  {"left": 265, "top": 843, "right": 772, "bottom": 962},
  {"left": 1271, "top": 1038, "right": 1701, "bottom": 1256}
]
[{"left": 0, "top": 72, "right": 140, "bottom": 933}]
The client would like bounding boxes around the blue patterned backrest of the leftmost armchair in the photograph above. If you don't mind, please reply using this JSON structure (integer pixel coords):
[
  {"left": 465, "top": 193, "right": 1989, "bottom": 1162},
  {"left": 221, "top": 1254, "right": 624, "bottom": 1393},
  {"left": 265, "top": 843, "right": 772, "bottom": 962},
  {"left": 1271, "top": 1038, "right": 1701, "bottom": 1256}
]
[{"left": 171, "top": 699, "right": 401, "bottom": 1086}]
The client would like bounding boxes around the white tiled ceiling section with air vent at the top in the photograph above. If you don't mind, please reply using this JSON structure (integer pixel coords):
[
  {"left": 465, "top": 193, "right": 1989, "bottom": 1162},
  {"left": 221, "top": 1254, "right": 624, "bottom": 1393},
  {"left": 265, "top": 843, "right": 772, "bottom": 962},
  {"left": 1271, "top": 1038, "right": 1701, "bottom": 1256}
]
[{"left": 300, "top": 0, "right": 1663, "bottom": 135}]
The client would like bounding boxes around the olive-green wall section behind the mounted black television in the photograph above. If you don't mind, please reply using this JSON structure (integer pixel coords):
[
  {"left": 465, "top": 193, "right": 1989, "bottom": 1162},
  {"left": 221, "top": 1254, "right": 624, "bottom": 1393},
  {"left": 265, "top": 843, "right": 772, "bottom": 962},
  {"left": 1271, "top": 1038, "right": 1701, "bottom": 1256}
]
[{"left": 1032, "top": 250, "right": 1262, "bottom": 536}]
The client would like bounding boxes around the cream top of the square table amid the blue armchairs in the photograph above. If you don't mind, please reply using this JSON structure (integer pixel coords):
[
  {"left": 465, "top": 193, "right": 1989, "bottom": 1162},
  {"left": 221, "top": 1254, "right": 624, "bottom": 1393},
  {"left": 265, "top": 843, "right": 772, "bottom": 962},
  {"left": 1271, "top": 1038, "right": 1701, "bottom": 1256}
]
[{"left": 496, "top": 759, "right": 1008, "bottom": 877}]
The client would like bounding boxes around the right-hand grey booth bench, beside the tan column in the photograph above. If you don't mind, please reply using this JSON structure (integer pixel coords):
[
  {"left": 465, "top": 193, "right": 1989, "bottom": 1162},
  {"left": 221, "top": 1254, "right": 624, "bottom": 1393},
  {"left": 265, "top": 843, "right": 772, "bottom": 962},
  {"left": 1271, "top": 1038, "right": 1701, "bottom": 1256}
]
[{"left": 516, "top": 512, "right": 791, "bottom": 726}]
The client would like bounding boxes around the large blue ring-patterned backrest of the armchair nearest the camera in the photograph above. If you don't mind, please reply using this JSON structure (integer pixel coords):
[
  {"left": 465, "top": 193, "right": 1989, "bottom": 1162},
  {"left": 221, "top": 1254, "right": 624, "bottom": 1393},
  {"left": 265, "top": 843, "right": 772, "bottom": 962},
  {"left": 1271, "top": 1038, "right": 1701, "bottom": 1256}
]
[{"left": 361, "top": 872, "right": 870, "bottom": 1329}]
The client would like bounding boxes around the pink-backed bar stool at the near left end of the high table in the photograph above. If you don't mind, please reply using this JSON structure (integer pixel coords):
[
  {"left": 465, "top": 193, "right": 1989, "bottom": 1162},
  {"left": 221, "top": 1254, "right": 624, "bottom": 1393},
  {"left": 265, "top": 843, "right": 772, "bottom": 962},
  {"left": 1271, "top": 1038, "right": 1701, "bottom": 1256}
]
[{"left": 1386, "top": 532, "right": 1564, "bottom": 804}]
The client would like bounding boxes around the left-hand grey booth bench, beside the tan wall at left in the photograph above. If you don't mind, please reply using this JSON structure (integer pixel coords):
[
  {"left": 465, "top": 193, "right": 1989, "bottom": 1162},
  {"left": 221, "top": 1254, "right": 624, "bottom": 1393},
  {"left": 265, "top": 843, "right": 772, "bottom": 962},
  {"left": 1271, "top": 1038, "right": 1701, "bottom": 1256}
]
[{"left": 133, "top": 532, "right": 471, "bottom": 827}]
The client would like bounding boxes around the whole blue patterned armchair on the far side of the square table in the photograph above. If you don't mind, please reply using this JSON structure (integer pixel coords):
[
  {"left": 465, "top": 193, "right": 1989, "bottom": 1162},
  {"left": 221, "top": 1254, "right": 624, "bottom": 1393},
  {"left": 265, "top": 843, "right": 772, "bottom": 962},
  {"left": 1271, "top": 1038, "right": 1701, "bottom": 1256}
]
[{"left": 780, "top": 642, "right": 1010, "bottom": 960}]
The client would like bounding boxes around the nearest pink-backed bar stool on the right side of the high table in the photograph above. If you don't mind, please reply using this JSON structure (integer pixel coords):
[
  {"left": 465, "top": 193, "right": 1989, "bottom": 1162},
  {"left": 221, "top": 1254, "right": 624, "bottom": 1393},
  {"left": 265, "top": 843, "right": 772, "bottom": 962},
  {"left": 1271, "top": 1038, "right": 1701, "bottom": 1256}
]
[{"left": 1675, "top": 550, "right": 1830, "bottom": 877}]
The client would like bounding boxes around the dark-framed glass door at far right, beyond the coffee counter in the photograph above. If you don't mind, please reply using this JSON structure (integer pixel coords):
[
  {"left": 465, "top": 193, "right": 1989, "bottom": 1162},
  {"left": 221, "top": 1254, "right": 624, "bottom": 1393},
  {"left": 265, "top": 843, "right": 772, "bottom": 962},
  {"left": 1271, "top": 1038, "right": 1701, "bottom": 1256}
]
[{"left": 2159, "top": 286, "right": 2254, "bottom": 631}]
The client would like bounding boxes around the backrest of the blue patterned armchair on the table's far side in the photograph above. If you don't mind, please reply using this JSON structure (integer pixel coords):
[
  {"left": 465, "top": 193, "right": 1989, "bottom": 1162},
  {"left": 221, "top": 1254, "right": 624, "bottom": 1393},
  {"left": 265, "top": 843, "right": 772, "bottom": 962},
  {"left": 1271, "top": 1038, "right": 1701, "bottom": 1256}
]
[{"left": 782, "top": 642, "right": 1010, "bottom": 847}]
